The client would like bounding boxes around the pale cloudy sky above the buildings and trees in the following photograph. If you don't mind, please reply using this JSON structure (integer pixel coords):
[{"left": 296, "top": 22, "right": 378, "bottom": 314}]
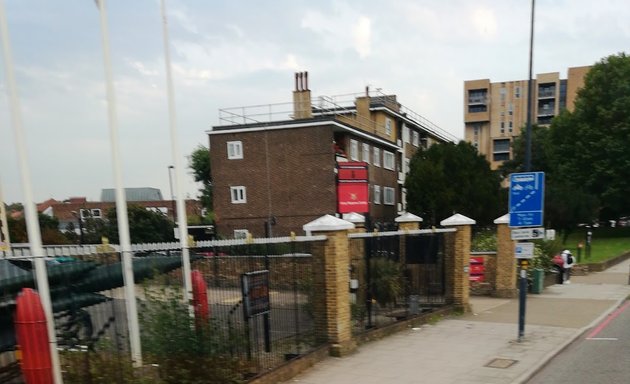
[{"left": 0, "top": 0, "right": 630, "bottom": 203}]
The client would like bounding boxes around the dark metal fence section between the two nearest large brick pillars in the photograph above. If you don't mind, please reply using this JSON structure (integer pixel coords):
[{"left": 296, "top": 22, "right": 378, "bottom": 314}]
[{"left": 350, "top": 229, "right": 454, "bottom": 333}]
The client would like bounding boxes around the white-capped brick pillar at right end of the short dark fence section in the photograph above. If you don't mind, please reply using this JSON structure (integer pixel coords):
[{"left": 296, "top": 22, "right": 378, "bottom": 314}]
[{"left": 440, "top": 214, "right": 476, "bottom": 312}]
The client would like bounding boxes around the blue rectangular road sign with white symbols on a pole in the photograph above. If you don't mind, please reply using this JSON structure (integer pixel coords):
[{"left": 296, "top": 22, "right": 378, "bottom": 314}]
[{"left": 509, "top": 172, "right": 545, "bottom": 228}]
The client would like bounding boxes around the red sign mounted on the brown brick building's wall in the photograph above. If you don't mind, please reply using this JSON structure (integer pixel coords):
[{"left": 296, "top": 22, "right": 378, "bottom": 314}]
[{"left": 337, "top": 161, "right": 370, "bottom": 213}]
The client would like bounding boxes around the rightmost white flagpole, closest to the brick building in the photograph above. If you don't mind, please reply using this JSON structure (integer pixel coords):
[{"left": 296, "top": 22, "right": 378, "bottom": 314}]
[{"left": 160, "top": 0, "right": 192, "bottom": 304}]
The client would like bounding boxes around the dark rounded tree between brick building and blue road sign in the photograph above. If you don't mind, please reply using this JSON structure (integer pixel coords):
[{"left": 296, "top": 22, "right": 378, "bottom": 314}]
[{"left": 405, "top": 141, "right": 507, "bottom": 225}]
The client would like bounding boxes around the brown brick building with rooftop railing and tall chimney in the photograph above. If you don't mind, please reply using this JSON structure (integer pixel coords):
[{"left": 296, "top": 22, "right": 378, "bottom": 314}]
[{"left": 207, "top": 73, "right": 457, "bottom": 237}]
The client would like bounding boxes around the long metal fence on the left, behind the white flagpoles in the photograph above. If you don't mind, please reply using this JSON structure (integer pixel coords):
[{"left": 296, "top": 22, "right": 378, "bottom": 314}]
[{"left": 0, "top": 236, "right": 325, "bottom": 383}]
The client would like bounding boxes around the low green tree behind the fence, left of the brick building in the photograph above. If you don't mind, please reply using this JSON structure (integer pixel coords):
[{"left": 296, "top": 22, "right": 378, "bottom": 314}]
[{"left": 105, "top": 204, "right": 174, "bottom": 243}]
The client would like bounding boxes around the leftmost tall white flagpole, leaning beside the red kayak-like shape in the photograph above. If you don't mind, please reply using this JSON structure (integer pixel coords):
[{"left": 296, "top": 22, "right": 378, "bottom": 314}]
[{"left": 0, "top": 0, "right": 63, "bottom": 384}]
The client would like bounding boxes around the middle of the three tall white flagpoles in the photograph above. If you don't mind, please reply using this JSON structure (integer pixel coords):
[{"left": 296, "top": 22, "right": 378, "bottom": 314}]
[{"left": 96, "top": 0, "right": 142, "bottom": 367}]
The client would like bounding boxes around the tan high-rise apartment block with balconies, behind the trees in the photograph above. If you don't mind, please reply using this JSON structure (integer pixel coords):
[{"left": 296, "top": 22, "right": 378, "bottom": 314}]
[{"left": 464, "top": 66, "right": 591, "bottom": 169}]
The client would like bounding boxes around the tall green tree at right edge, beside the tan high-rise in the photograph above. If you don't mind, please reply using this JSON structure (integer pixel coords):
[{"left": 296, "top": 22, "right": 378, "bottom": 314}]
[{"left": 550, "top": 53, "right": 630, "bottom": 219}]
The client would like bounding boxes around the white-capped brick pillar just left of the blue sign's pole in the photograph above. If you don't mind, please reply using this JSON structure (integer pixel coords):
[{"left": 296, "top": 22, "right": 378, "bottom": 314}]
[{"left": 492, "top": 215, "right": 518, "bottom": 298}]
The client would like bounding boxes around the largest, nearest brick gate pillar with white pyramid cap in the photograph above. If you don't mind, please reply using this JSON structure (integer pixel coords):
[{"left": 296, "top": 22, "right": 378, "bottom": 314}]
[{"left": 303, "top": 215, "right": 356, "bottom": 356}]
